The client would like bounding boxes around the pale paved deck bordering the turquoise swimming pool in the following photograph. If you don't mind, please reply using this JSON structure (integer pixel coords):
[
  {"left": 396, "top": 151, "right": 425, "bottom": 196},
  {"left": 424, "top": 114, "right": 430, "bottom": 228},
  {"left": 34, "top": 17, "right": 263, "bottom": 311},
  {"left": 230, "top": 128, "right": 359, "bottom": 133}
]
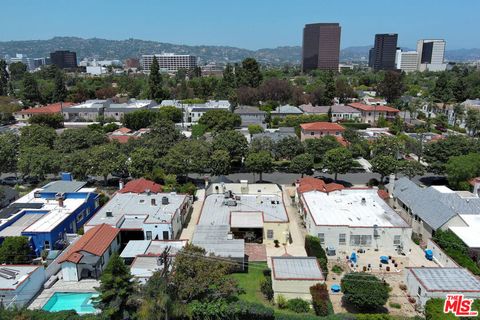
[{"left": 28, "top": 279, "right": 100, "bottom": 310}]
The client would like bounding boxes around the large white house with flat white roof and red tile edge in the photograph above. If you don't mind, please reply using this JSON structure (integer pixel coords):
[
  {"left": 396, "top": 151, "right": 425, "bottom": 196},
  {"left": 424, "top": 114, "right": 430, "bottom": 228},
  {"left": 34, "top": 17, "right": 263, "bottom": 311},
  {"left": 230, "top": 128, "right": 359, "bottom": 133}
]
[{"left": 297, "top": 177, "right": 412, "bottom": 254}]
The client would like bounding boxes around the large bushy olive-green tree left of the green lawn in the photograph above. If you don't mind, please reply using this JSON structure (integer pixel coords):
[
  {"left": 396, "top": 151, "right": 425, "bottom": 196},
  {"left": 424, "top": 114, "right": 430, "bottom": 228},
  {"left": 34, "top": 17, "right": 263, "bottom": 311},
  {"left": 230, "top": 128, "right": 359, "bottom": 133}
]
[{"left": 171, "top": 244, "right": 240, "bottom": 303}]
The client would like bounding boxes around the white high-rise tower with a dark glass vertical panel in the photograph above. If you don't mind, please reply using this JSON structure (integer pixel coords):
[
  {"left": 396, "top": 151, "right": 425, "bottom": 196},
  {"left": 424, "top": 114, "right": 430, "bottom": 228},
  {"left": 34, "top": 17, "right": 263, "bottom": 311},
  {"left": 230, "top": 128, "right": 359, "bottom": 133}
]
[{"left": 417, "top": 39, "right": 447, "bottom": 71}]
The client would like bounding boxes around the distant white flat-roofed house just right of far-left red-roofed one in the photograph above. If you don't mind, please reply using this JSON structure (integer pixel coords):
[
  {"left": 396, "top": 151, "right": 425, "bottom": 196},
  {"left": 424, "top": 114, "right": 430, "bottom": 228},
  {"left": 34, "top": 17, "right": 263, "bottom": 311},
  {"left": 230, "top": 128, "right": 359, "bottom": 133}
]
[{"left": 62, "top": 99, "right": 112, "bottom": 122}]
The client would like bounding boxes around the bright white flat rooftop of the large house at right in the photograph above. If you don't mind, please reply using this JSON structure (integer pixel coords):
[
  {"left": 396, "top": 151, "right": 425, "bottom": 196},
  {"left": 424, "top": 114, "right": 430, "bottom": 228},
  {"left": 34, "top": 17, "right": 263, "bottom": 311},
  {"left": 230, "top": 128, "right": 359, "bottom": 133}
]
[{"left": 302, "top": 189, "right": 409, "bottom": 228}]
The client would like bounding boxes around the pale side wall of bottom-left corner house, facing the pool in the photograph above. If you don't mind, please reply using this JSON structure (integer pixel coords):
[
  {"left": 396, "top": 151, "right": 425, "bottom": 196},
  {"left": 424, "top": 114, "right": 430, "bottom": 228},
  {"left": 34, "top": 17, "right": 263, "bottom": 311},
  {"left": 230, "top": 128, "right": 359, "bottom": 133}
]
[{"left": 0, "top": 266, "right": 46, "bottom": 307}]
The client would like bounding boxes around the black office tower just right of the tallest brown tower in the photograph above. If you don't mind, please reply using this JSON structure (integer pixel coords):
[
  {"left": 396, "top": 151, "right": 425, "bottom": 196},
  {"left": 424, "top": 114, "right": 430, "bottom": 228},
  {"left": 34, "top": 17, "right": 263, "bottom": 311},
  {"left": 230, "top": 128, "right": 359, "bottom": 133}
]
[{"left": 369, "top": 33, "right": 398, "bottom": 71}]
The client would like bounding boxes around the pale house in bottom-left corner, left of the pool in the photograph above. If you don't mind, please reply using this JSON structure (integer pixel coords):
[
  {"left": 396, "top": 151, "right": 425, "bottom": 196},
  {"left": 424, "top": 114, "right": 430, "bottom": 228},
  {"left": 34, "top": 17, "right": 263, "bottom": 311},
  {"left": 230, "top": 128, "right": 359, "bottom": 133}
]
[{"left": 0, "top": 264, "right": 46, "bottom": 309}]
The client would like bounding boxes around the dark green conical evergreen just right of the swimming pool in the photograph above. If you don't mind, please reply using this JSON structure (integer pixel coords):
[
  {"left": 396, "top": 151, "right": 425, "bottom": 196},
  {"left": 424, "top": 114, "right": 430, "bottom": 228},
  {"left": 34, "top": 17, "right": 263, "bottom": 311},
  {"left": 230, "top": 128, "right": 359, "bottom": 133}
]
[{"left": 93, "top": 253, "right": 136, "bottom": 320}]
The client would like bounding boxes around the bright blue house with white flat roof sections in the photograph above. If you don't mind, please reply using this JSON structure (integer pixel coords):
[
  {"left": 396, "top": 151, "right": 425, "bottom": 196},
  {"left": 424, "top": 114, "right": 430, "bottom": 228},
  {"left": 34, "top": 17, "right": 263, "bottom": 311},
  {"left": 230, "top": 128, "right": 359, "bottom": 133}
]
[{"left": 0, "top": 174, "right": 100, "bottom": 256}]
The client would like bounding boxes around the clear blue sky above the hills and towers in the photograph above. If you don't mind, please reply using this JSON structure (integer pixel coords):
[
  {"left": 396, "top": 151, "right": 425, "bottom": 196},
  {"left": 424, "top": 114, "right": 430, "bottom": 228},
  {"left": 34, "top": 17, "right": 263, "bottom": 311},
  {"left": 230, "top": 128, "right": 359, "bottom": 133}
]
[{"left": 0, "top": 0, "right": 480, "bottom": 49}]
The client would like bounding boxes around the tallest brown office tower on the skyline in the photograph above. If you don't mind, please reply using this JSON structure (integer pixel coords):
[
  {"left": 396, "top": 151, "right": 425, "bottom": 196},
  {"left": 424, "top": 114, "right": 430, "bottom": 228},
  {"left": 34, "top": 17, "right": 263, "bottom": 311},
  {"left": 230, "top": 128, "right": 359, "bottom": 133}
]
[{"left": 302, "top": 23, "right": 342, "bottom": 72}]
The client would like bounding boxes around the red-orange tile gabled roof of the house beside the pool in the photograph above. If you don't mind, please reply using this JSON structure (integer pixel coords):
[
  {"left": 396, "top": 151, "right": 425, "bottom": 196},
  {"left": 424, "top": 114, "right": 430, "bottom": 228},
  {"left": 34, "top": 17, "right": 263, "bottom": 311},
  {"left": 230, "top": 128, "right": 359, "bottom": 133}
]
[{"left": 59, "top": 224, "right": 120, "bottom": 263}]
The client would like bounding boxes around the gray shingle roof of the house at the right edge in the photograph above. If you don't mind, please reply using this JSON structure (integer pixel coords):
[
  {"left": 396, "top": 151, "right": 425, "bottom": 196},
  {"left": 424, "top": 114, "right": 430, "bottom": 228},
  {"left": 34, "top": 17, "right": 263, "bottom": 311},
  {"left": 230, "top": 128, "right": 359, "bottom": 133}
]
[{"left": 393, "top": 177, "right": 480, "bottom": 230}]
